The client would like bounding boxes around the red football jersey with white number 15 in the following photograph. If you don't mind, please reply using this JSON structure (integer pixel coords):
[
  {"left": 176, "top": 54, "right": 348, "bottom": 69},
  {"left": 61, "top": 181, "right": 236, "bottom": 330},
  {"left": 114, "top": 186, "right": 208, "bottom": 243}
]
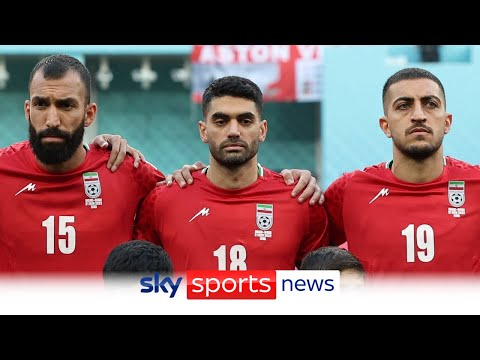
[{"left": 0, "top": 141, "right": 164, "bottom": 274}]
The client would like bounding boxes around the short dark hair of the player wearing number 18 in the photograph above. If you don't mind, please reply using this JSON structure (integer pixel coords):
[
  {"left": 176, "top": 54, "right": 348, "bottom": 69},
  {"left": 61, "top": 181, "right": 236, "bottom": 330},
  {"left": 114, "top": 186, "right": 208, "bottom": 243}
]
[{"left": 202, "top": 76, "right": 263, "bottom": 116}]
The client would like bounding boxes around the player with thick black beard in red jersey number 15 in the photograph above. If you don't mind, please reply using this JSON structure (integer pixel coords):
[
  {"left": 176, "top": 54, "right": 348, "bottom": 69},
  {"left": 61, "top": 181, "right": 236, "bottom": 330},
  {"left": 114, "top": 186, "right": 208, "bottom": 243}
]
[{"left": 0, "top": 55, "right": 164, "bottom": 276}]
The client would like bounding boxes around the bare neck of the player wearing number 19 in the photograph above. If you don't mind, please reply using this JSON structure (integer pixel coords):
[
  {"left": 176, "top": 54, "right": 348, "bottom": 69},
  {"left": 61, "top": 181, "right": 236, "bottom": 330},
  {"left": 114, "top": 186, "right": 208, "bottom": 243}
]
[{"left": 391, "top": 149, "right": 445, "bottom": 184}]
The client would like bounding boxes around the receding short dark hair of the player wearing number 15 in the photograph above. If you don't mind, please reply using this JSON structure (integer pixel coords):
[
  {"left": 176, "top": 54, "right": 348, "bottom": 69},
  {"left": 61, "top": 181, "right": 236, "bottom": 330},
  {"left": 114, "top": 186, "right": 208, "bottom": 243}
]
[{"left": 28, "top": 54, "right": 92, "bottom": 104}]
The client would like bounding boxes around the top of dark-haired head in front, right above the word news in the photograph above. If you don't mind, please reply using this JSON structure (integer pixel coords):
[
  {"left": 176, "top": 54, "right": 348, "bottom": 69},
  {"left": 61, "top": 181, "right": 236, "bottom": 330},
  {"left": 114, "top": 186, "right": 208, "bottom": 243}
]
[{"left": 300, "top": 246, "right": 365, "bottom": 273}]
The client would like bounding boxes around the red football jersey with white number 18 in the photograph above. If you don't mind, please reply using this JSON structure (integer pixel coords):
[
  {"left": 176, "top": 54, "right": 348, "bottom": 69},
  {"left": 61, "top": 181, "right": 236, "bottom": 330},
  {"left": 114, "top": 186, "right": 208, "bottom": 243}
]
[{"left": 135, "top": 168, "right": 328, "bottom": 272}]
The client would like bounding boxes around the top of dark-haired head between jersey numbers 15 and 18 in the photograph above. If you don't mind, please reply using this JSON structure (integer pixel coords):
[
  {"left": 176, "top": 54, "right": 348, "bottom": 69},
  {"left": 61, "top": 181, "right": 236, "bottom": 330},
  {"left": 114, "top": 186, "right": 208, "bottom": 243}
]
[{"left": 103, "top": 240, "right": 173, "bottom": 278}]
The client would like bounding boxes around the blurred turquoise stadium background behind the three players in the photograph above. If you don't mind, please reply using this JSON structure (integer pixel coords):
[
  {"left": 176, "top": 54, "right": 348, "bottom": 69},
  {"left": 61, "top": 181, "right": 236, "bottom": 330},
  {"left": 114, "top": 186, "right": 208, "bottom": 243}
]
[{"left": 0, "top": 45, "right": 472, "bottom": 188}]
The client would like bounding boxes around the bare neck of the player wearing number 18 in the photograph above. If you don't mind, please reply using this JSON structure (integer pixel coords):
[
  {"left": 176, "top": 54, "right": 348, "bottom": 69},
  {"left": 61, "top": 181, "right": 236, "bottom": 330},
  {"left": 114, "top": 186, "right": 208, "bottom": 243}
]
[{"left": 207, "top": 156, "right": 259, "bottom": 190}]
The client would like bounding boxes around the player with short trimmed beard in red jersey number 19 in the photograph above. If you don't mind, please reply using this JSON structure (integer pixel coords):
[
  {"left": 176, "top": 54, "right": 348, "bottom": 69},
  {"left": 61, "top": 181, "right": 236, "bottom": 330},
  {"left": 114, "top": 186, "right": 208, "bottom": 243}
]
[{"left": 325, "top": 68, "right": 480, "bottom": 275}]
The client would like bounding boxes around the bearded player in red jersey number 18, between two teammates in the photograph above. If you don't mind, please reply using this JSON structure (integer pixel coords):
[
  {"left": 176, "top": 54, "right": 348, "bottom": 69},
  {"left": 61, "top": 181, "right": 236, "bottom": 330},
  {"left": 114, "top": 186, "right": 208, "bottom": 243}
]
[{"left": 134, "top": 76, "right": 327, "bottom": 273}]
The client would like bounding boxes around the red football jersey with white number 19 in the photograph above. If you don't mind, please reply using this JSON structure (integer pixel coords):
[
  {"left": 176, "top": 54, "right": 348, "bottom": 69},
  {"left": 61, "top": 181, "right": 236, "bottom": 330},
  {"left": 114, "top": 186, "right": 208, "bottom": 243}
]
[{"left": 325, "top": 157, "right": 480, "bottom": 273}]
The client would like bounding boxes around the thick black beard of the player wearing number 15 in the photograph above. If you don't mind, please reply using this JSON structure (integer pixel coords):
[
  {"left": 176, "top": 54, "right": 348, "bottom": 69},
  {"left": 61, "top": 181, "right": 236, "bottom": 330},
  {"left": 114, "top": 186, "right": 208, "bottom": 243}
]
[{"left": 28, "top": 121, "right": 85, "bottom": 165}]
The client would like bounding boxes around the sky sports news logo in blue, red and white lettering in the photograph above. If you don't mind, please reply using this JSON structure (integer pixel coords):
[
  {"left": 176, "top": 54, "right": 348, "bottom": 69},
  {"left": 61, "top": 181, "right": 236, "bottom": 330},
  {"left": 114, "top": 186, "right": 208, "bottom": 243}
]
[{"left": 140, "top": 270, "right": 340, "bottom": 300}]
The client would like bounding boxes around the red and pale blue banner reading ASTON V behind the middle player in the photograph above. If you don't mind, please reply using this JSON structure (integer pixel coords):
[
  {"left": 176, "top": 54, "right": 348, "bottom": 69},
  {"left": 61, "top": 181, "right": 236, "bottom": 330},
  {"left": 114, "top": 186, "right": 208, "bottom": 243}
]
[{"left": 191, "top": 45, "right": 324, "bottom": 103}]
